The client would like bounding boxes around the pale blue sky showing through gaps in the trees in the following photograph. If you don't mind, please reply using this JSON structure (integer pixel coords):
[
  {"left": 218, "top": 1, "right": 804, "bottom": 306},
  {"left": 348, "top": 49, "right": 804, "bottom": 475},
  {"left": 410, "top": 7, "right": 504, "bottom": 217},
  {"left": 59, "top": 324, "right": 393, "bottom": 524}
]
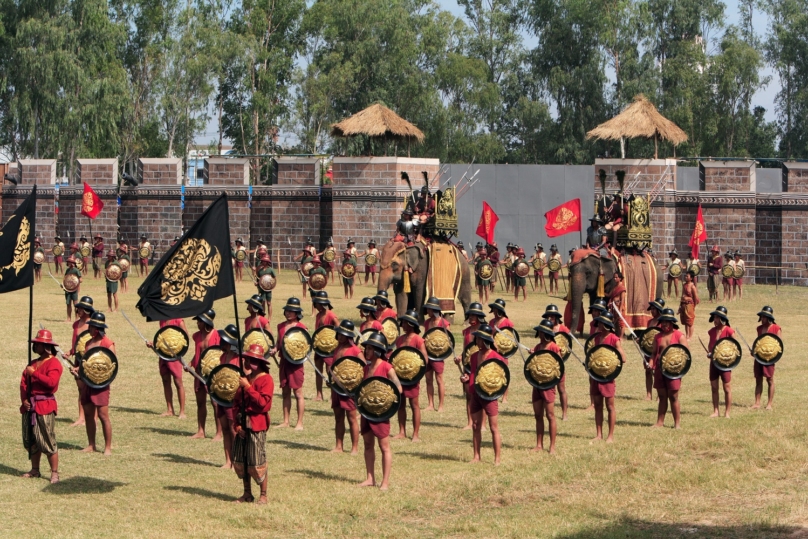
[{"left": 196, "top": 0, "right": 780, "bottom": 145}]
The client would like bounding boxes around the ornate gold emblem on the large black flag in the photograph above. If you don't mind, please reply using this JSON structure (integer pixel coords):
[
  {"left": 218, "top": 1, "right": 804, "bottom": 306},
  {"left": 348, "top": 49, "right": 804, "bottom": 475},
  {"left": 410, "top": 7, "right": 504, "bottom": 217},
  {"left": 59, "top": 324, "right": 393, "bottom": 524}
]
[{"left": 159, "top": 238, "right": 222, "bottom": 305}]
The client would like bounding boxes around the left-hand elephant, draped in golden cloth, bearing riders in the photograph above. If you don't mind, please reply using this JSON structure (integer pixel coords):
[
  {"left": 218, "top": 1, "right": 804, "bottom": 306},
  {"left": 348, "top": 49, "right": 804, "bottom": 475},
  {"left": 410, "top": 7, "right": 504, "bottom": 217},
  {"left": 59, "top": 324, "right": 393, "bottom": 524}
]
[{"left": 377, "top": 240, "right": 472, "bottom": 320}]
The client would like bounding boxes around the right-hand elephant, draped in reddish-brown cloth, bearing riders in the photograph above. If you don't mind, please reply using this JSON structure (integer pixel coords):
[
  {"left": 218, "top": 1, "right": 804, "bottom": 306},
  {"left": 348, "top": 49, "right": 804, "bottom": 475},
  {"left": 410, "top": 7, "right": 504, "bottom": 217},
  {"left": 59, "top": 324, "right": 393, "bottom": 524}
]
[{"left": 568, "top": 255, "right": 663, "bottom": 331}]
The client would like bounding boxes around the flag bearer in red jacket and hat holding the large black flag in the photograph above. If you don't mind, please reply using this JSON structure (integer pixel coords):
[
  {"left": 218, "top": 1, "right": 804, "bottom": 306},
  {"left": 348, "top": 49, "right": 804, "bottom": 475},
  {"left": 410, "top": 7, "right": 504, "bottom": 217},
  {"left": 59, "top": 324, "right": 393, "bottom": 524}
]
[{"left": 232, "top": 344, "right": 275, "bottom": 505}]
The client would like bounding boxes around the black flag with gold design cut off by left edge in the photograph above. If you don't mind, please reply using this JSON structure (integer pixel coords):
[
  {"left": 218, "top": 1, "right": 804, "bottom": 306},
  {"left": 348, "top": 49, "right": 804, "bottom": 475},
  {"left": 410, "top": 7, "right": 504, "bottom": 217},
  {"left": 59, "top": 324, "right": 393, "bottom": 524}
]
[{"left": 0, "top": 185, "right": 36, "bottom": 294}]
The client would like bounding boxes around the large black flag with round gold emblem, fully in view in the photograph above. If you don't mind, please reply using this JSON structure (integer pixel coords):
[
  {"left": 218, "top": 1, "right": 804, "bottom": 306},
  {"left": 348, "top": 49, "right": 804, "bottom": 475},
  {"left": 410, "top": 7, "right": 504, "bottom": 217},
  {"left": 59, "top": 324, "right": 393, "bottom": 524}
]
[{"left": 137, "top": 195, "right": 236, "bottom": 321}]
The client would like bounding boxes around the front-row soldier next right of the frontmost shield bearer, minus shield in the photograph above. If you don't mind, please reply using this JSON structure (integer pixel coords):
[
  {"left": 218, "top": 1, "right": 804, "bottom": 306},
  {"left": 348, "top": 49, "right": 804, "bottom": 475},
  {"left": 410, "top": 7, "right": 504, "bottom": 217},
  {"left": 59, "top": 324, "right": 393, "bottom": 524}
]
[{"left": 460, "top": 324, "right": 508, "bottom": 466}]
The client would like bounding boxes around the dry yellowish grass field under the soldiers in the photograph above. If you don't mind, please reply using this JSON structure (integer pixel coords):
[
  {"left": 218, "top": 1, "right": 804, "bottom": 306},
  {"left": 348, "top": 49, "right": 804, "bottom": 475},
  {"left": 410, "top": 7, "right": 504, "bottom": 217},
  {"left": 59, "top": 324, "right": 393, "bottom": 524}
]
[{"left": 0, "top": 272, "right": 808, "bottom": 537}]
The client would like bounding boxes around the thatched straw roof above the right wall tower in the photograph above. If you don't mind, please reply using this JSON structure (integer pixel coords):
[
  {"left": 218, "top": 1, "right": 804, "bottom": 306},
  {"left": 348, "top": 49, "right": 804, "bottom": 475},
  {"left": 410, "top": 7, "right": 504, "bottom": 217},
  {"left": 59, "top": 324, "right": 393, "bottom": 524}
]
[{"left": 586, "top": 94, "right": 687, "bottom": 159}]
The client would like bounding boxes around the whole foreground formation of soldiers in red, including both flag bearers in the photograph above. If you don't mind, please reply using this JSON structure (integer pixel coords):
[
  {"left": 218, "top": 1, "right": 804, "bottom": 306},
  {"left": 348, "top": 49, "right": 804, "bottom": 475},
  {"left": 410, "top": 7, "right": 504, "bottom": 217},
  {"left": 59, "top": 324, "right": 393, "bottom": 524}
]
[{"left": 20, "top": 282, "right": 783, "bottom": 503}]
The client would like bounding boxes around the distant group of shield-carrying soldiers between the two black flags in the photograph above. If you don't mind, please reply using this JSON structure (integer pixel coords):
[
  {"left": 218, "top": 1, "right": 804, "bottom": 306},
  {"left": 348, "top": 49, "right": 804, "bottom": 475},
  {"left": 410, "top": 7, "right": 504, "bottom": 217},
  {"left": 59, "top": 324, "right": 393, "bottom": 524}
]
[{"left": 43, "top": 234, "right": 179, "bottom": 322}]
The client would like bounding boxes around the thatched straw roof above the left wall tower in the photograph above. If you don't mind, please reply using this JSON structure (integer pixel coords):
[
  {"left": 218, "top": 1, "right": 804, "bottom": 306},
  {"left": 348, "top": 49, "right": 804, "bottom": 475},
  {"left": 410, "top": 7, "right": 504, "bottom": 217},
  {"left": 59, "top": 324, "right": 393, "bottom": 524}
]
[{"left": 331, "top": 103, "right": 424, "bottom": 155}]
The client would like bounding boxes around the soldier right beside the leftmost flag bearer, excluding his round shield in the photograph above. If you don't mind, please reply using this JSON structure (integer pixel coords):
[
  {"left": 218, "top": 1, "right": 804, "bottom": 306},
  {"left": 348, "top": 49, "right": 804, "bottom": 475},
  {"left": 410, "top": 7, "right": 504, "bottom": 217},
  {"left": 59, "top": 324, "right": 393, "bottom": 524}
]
[{"left": 70, "top": 311, "right": 115, "bottom": 455}]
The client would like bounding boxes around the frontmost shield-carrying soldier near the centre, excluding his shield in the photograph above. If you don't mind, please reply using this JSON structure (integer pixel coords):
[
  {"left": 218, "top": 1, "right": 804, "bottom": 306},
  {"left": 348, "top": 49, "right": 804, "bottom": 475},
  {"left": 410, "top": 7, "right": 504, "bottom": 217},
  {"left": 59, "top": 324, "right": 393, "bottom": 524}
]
[{"left": 359, "top": 332, "right": 404, "bottom": 490}]
